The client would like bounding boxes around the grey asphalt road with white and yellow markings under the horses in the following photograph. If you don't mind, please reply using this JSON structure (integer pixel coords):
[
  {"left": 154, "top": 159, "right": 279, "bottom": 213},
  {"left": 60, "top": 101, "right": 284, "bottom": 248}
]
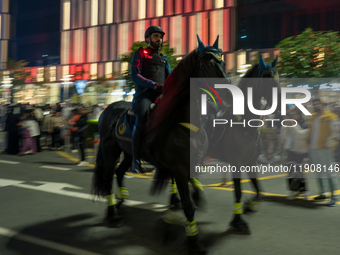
[{"left": 0, "top": 148, "right": 340, "bottom": 255}]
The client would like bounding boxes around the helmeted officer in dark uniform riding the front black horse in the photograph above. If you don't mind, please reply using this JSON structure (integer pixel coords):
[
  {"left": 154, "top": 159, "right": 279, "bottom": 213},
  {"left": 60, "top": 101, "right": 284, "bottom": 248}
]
[{"left": 131, "top": 26, "right": 171, "bottom": 172}]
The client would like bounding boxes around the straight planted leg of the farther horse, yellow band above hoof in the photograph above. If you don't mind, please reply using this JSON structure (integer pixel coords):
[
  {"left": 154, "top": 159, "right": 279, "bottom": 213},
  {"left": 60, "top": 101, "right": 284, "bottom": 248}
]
[{"left": 230, "top": 173, "right": 250, "bottom": 235}]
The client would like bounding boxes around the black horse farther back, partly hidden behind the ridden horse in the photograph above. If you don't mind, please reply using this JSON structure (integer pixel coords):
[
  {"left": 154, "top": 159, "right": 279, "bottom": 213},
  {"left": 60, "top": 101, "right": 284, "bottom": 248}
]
[{"left": 203, "top": 55, "right": 281, "bottom": 234}]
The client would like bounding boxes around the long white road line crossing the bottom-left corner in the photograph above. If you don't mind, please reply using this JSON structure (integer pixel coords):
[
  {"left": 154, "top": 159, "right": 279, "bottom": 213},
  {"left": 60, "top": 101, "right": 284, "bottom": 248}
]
[{"left": 0, "top": 227, "right": 100, "bottom": 255}]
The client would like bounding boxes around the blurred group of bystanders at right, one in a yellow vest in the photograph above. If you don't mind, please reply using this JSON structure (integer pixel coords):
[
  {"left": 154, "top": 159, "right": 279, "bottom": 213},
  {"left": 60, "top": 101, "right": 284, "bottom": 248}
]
[{"left": 258, "top": 99, "right": 340, "bottom": 205}]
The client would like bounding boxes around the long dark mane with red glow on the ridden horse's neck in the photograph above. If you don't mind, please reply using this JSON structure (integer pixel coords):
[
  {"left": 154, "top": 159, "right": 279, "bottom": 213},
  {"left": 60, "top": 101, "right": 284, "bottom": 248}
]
[{"left": 147, "top": 49, "right": 197, "bottom": 131}]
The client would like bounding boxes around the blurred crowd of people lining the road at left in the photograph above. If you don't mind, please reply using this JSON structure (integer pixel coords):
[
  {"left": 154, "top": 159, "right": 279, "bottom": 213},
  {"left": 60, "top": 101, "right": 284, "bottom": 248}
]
[{"left": 0, "top": 103, "right": 104, "bottom": 166}]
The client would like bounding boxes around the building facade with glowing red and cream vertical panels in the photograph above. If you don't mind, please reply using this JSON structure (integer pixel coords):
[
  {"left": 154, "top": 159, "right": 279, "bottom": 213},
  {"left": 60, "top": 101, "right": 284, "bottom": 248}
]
[{"left": 61, "top": 0, "right": 242, "bottom": 79}]
